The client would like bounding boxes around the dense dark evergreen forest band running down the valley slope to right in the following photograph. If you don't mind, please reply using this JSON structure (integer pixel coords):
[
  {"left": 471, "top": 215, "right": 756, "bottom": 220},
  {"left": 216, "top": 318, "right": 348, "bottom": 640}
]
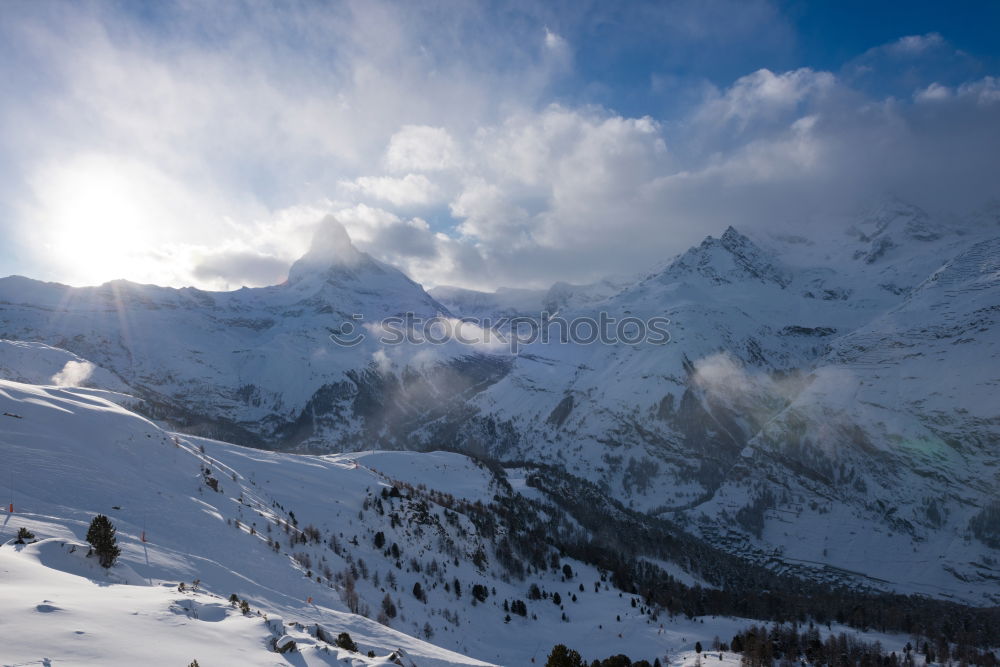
[{"left": 424, "top": 461, "right": 1000, "bottom": 646}]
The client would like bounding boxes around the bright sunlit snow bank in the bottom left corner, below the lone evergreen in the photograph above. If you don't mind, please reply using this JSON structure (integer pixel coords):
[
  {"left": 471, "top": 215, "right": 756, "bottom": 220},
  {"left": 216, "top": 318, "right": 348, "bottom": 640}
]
[{"left": 0, "top": 538, "right": 426, "bottom": 666}]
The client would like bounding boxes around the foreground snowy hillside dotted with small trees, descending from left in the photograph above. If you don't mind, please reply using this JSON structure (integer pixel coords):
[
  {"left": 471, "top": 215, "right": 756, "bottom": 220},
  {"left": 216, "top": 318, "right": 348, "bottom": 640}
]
[{"left": 0, "top": 381, "right": 980, "bottom": 667}]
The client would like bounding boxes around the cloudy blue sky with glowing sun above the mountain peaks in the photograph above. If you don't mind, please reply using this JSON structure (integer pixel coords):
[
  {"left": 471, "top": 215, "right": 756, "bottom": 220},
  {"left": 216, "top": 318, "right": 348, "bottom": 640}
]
[{"left": 0, "top": 0, "right": 1000, "bottom": 289}]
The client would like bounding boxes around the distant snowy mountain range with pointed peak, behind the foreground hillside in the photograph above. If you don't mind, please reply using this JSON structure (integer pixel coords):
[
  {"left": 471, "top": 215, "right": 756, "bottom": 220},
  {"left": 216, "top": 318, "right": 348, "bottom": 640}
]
[{"left": 0, "top": 199, "right": 1000, "bottom": 624}]
